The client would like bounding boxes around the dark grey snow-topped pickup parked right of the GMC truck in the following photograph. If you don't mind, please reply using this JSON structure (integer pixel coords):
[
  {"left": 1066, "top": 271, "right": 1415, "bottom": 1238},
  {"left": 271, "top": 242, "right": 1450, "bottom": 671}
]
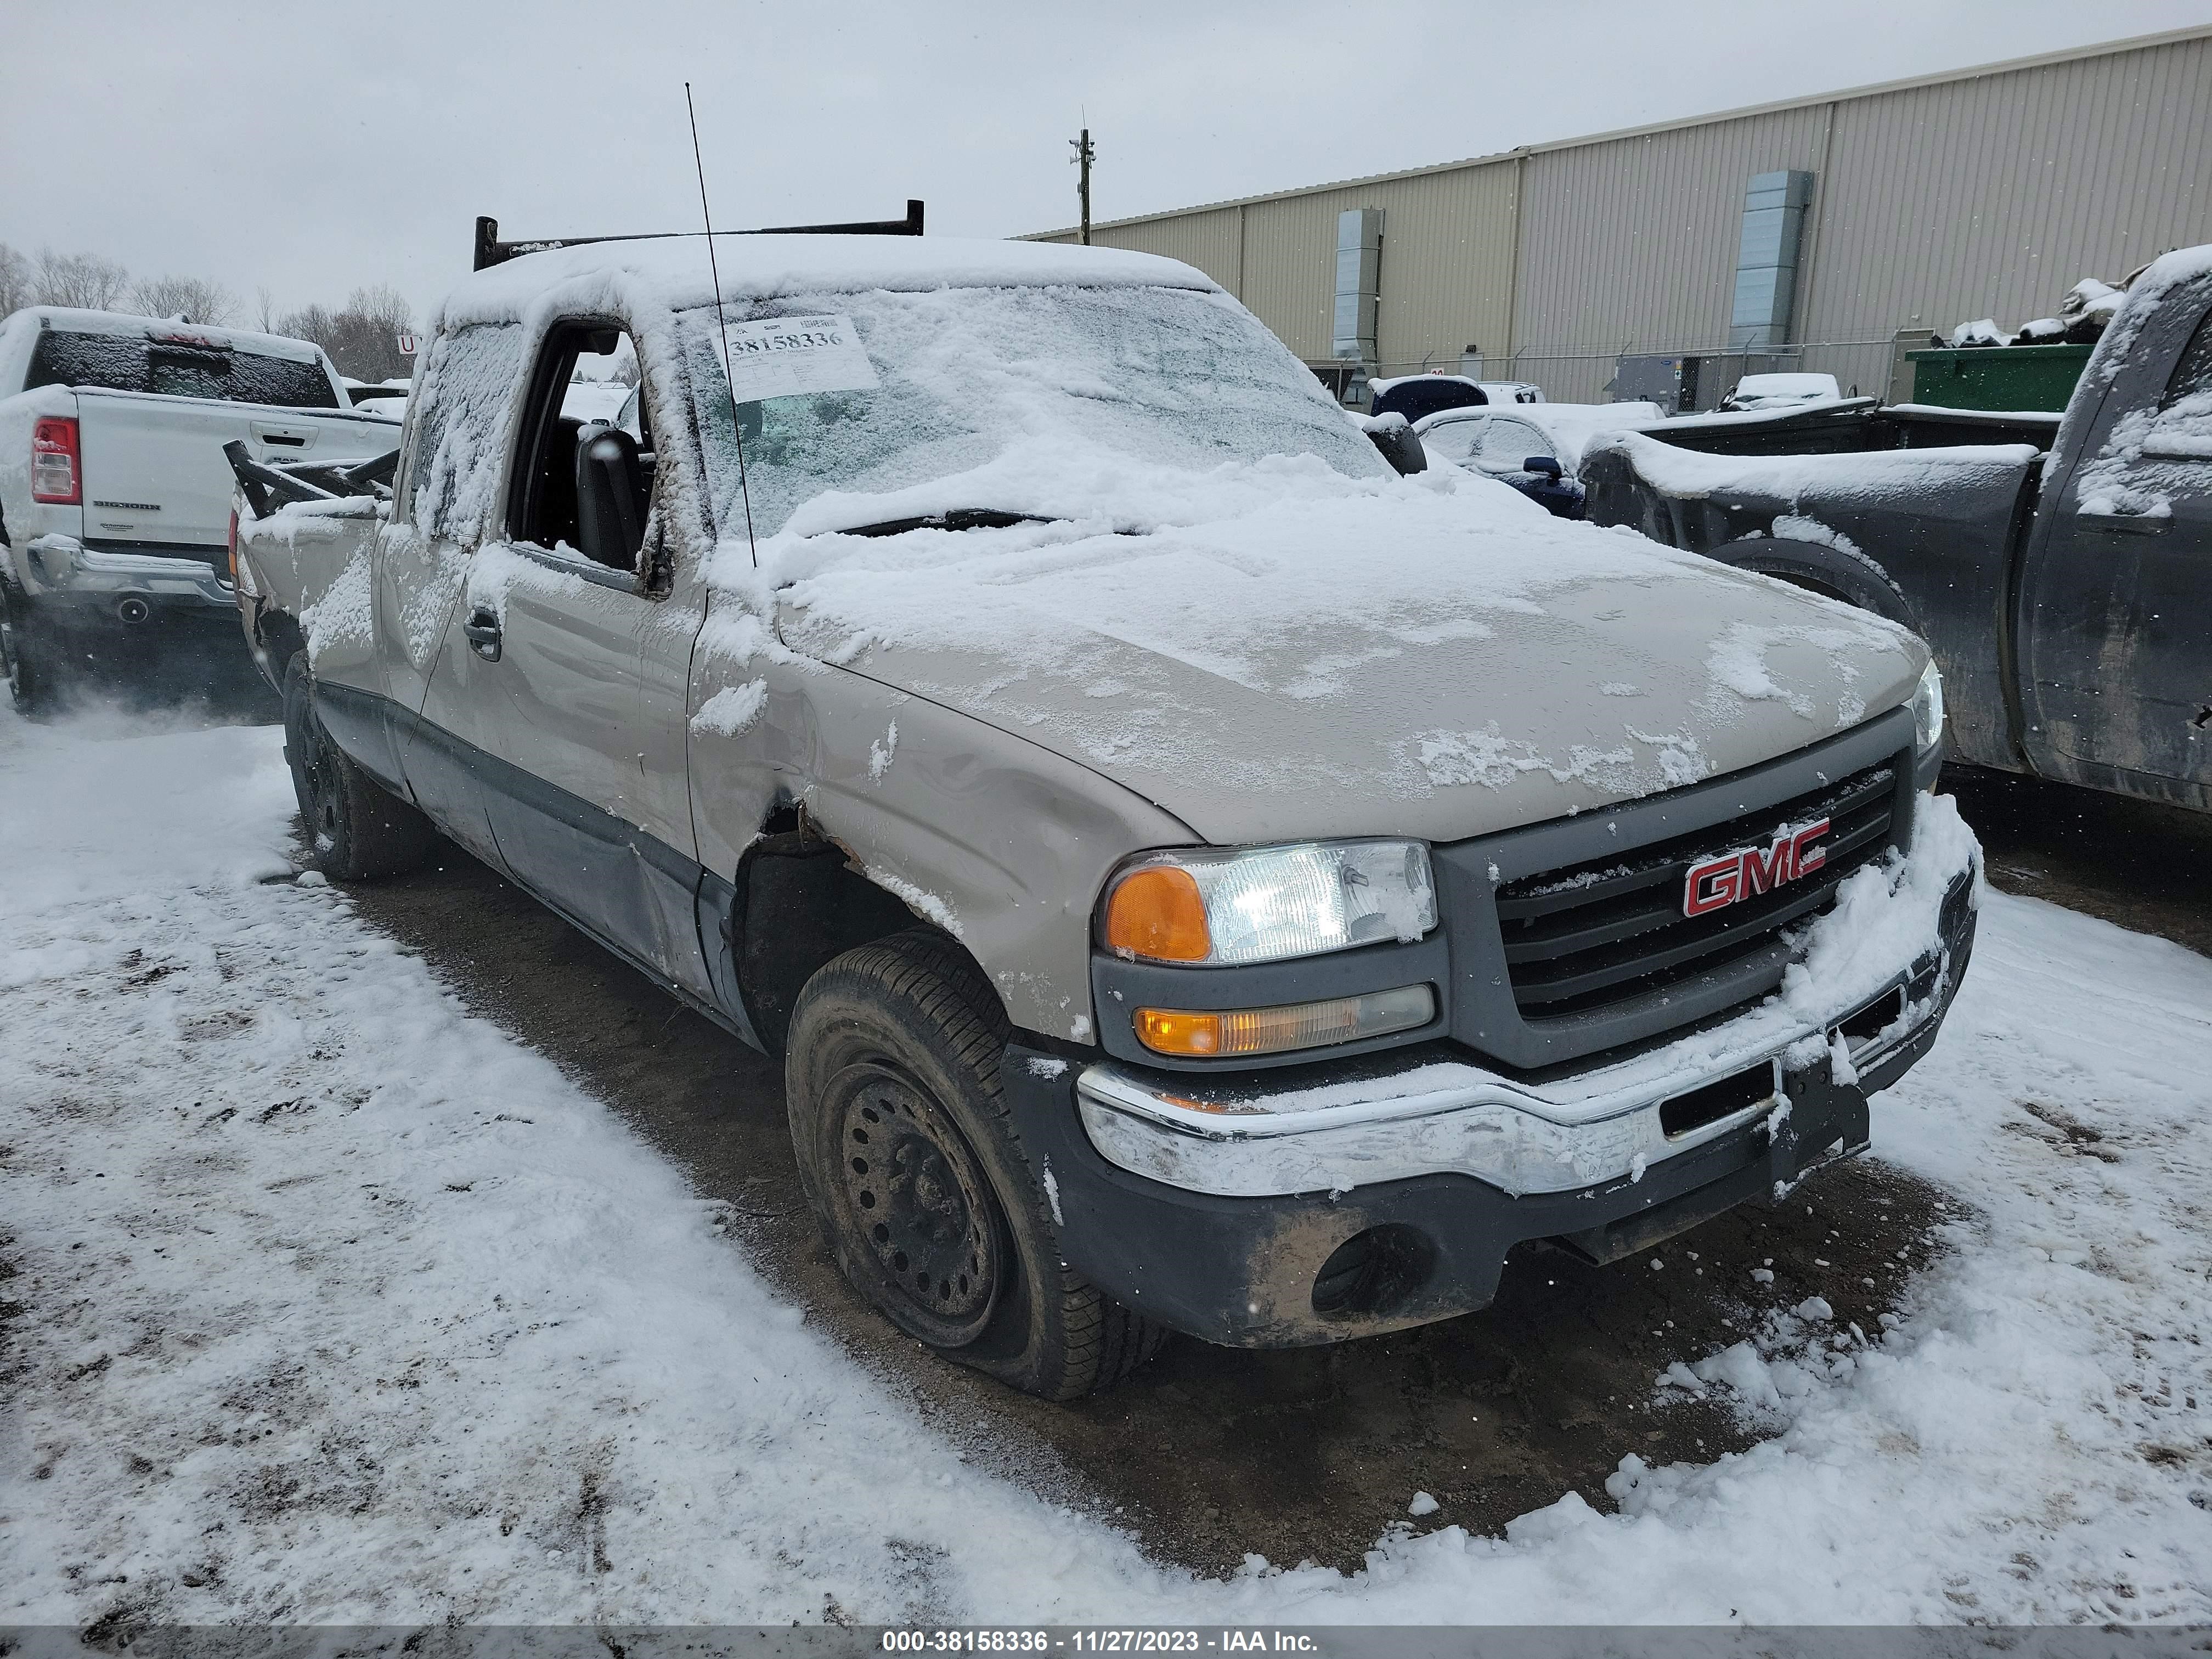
[{"left": 1582, "top": 246, "right": 2212, "bottom": 810}]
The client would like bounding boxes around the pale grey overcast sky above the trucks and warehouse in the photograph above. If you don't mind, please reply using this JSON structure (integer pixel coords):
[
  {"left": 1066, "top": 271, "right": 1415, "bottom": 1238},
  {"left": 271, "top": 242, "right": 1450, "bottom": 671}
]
[{"left": 0, "top": 0, "right": 2212, "bottom": 331}]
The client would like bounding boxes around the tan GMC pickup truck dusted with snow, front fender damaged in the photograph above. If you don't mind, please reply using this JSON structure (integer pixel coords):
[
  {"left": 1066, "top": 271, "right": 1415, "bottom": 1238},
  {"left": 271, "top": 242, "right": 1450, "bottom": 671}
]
[{"left": 239, "top": 236, "right": 1978, "bottom": 1396}]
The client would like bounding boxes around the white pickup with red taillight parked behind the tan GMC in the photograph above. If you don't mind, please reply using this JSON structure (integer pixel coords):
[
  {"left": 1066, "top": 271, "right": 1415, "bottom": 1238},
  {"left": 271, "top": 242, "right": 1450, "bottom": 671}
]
[{"left": 0, "top": 305, "right": 400, "bottom": 710}]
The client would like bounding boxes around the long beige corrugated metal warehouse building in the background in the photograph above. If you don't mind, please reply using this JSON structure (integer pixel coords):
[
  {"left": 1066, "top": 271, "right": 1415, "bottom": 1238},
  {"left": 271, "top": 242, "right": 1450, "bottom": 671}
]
[{"left": 1037, "top": 26, "right": 2212, "bottom": 407}]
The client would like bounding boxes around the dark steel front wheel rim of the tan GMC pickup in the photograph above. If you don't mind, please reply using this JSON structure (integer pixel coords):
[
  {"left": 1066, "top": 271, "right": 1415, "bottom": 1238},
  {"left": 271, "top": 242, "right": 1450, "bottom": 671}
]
[{"left": 827, "top": 1062, "right": 1011, "bottom": 1347}]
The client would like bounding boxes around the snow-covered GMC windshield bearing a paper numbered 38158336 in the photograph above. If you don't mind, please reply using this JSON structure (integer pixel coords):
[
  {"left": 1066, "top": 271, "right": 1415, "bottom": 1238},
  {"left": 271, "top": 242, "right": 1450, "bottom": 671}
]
[{"left": 681, "top": 287, "right": 1389, "bottom": 538}]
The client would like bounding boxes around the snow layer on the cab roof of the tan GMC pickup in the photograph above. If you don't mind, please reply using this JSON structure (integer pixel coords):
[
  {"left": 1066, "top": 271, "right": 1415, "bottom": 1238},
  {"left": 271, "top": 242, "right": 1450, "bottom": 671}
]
[{"left": 436, "top": 232, "right": 1219, "bottom": 325}]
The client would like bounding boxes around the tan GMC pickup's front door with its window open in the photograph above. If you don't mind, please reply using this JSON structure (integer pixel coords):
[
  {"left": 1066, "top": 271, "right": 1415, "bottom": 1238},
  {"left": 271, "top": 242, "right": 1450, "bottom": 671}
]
[{"left": 427, "top": 319, "right": 710, "bottom": 995}]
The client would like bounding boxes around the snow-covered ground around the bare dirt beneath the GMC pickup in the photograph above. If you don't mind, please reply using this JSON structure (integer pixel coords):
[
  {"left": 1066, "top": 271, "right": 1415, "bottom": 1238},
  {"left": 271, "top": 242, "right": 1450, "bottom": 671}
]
[{"left": 0, "top": 714, "right": 2212, "bottom": 1637}]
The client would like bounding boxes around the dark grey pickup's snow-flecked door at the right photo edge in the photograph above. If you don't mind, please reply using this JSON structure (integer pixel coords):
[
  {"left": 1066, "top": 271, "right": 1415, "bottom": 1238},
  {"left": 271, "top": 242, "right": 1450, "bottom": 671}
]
[{"left": 2019, "top": 276, "right": 2212, "bottom": 808}]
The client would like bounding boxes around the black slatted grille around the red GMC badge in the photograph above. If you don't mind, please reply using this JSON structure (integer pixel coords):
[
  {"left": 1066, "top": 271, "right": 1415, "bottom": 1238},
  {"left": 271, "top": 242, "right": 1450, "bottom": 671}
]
[{"left": 1498, "top": 763, "right": 1898, "bottom": 1022}]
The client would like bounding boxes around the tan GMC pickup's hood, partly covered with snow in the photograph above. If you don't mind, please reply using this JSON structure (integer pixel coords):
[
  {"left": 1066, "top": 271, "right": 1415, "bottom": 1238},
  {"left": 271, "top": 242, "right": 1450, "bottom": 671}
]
[{"left": 756, "top": 458, "right": 1927, "bottom": 843}]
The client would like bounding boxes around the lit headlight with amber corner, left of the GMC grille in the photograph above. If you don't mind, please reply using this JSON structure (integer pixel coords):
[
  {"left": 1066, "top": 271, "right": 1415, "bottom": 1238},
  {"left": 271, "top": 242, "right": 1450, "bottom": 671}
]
[{"left": 1099, "top": 840, "right": 1436, "bottom": 967}]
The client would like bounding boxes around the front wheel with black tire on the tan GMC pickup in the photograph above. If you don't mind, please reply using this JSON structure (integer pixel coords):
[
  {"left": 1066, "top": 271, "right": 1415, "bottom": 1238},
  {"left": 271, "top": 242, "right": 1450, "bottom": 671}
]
[{"left": 783, "top": 931, "right": 1166, "bottom": 1400}]
